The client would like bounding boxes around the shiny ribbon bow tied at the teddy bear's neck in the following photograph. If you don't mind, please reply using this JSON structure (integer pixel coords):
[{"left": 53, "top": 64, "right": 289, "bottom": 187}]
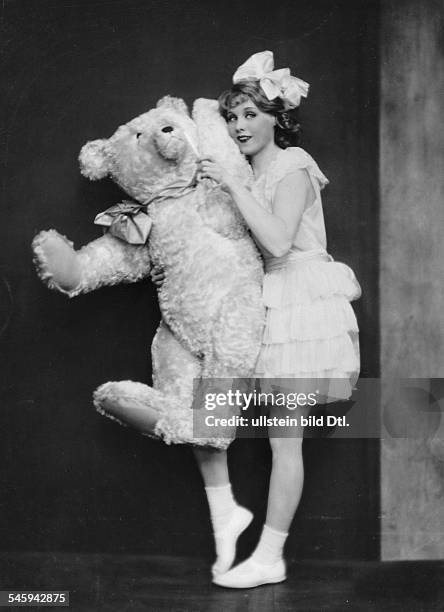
[{"left": 94, "top": 200, "right": 153, "bottom": 244}]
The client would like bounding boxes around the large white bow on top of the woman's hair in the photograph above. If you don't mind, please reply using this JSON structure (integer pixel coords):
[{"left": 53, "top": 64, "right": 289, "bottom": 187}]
[{"left": 233, "top": 51, "right": 310, "bottom": 108}]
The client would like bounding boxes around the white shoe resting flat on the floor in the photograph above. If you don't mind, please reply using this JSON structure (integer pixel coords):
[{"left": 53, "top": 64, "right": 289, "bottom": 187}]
[{"left": 213, "top": 557, "right": 287, "bottom": 589}]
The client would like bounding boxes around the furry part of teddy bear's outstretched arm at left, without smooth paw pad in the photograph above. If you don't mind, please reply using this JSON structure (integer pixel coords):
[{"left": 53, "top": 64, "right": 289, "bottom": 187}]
[{"left": 69, "top": 233, "right": 151, "bottom": 297}]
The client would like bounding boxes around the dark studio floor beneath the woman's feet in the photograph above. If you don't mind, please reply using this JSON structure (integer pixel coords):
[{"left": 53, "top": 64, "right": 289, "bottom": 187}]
[{"left": 0, "top": 553, "right": 444, "bottom": 612}]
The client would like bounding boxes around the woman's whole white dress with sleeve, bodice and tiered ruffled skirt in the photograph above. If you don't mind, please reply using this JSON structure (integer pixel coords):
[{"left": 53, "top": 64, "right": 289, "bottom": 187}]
[{"left": 252, "top": 147, "right": 361, "bottom": 403}]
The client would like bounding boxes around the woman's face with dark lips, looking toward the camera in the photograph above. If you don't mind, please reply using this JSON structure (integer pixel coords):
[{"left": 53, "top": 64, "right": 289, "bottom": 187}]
[{"left": 226, "top": 99, "right": 275, "bottom": 157}]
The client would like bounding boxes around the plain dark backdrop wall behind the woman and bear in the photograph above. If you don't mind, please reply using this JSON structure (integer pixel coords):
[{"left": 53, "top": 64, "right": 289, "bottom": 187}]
[{"left": 0, "top": 0, "right": 378, "bottom": 557}]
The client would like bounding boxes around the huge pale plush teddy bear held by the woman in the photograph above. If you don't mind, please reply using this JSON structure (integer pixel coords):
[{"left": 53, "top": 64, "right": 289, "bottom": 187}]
[{"left": 33, "top": 96, "right": 264, "bottom": 448}]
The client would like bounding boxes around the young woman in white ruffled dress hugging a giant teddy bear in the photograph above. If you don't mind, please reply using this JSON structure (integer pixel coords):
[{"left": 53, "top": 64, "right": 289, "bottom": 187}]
[{"left": 160, "top": 51, "right": 360, "bottom": 588}]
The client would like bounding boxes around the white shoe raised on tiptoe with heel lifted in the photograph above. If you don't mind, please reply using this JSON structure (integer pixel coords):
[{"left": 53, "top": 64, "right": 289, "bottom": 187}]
[{"left": 211, "top": 506, "right": 253, "bottom": 576}]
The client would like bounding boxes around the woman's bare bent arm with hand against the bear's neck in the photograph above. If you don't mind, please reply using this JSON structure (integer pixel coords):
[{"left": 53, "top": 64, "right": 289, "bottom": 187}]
[{"left": 202, "top": 160, "right": 315, "bottom": 257}]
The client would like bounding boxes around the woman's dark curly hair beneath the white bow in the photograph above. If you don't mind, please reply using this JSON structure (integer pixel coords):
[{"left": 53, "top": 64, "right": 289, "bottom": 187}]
[{"left": 218, "top": 79, "right": 301, "bottom": 149}]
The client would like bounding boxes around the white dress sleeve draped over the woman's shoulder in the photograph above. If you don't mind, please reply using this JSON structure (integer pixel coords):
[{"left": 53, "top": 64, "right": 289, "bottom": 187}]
[{"left": 267, "top": 147, "right": 328, "bottom": 198}]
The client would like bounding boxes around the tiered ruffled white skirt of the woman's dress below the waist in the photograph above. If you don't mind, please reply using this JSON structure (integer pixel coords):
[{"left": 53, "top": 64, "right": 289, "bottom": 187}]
[{"left": 256, "top": 251, "right": 361, "bottom": 403}]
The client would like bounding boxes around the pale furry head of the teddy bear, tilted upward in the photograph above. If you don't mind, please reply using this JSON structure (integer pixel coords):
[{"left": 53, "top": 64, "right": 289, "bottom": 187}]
[{"left": 79, "top": 96, "right": 198, "bottom": 204}]
